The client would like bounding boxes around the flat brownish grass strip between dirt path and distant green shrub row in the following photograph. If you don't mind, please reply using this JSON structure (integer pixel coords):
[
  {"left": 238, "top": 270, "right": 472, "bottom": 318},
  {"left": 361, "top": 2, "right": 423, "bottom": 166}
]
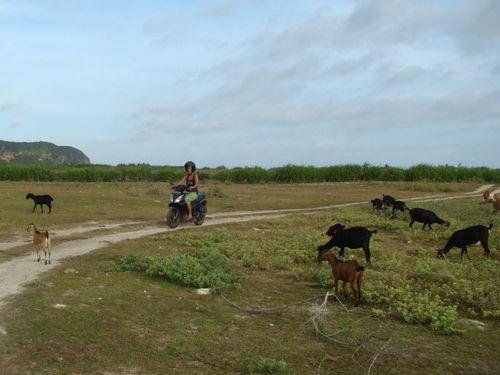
[{"left": 0, "top": 182, "right": 479, "bottom": 242}]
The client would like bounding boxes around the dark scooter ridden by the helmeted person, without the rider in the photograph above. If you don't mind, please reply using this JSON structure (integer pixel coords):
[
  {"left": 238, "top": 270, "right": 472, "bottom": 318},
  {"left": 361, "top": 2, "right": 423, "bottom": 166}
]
[{"left": 167, "top": 183, "right": 207, "bottom": 228}]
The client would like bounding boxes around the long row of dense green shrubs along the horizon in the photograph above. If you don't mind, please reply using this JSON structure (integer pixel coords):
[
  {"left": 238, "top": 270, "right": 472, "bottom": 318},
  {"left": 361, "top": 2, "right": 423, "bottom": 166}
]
[{"left": 0, "top": 163, "right": 500, "bottom": 184}]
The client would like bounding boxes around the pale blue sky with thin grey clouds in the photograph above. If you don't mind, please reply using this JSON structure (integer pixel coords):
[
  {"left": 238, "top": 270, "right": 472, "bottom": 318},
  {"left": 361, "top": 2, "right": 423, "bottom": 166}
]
[{"left": 0, "top": 0, "right": 500, "bottom": 168}]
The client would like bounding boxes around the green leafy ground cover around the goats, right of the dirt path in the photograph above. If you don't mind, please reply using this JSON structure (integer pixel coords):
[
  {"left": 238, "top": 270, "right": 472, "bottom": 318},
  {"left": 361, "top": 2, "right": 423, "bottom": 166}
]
[{"left": 155, "top": 200, "right": 500, "bottom": 334}]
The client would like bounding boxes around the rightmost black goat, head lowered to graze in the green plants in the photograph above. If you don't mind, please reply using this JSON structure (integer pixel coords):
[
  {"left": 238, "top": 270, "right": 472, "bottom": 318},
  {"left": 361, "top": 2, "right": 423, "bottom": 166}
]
[{"left": 438, "top": 224, "right": 493, "bottom": 260}]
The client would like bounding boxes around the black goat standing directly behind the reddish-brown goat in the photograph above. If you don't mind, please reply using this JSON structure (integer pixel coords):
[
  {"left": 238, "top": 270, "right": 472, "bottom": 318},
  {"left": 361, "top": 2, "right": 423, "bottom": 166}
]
[{"left": 318, "top": 224, "right": 377, "bottom": 263}]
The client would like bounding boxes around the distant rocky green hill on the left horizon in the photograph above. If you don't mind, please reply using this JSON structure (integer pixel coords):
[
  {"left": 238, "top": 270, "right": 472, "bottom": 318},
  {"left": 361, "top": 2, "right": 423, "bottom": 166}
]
[{"left": 0, "top": 140, "right": 90, "bottom": 164}]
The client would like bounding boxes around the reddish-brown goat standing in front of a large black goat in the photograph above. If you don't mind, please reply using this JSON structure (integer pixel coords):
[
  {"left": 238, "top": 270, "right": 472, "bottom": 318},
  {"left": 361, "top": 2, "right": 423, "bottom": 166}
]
[{"left": 317, "top": 246, "right": 365, "bottom": 306}]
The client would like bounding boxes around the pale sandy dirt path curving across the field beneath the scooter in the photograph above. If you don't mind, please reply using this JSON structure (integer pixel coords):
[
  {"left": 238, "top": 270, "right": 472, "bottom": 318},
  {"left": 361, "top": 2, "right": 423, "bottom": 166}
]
[{"left": 0, "top": 185, "right": 492, "bottom": 312}]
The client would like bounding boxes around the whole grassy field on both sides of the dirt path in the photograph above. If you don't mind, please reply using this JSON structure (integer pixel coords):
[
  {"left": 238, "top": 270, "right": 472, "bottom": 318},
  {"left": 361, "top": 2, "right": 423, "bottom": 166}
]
[{"left": 0, "top": 183, "right": 500, "bottom": 374}]
